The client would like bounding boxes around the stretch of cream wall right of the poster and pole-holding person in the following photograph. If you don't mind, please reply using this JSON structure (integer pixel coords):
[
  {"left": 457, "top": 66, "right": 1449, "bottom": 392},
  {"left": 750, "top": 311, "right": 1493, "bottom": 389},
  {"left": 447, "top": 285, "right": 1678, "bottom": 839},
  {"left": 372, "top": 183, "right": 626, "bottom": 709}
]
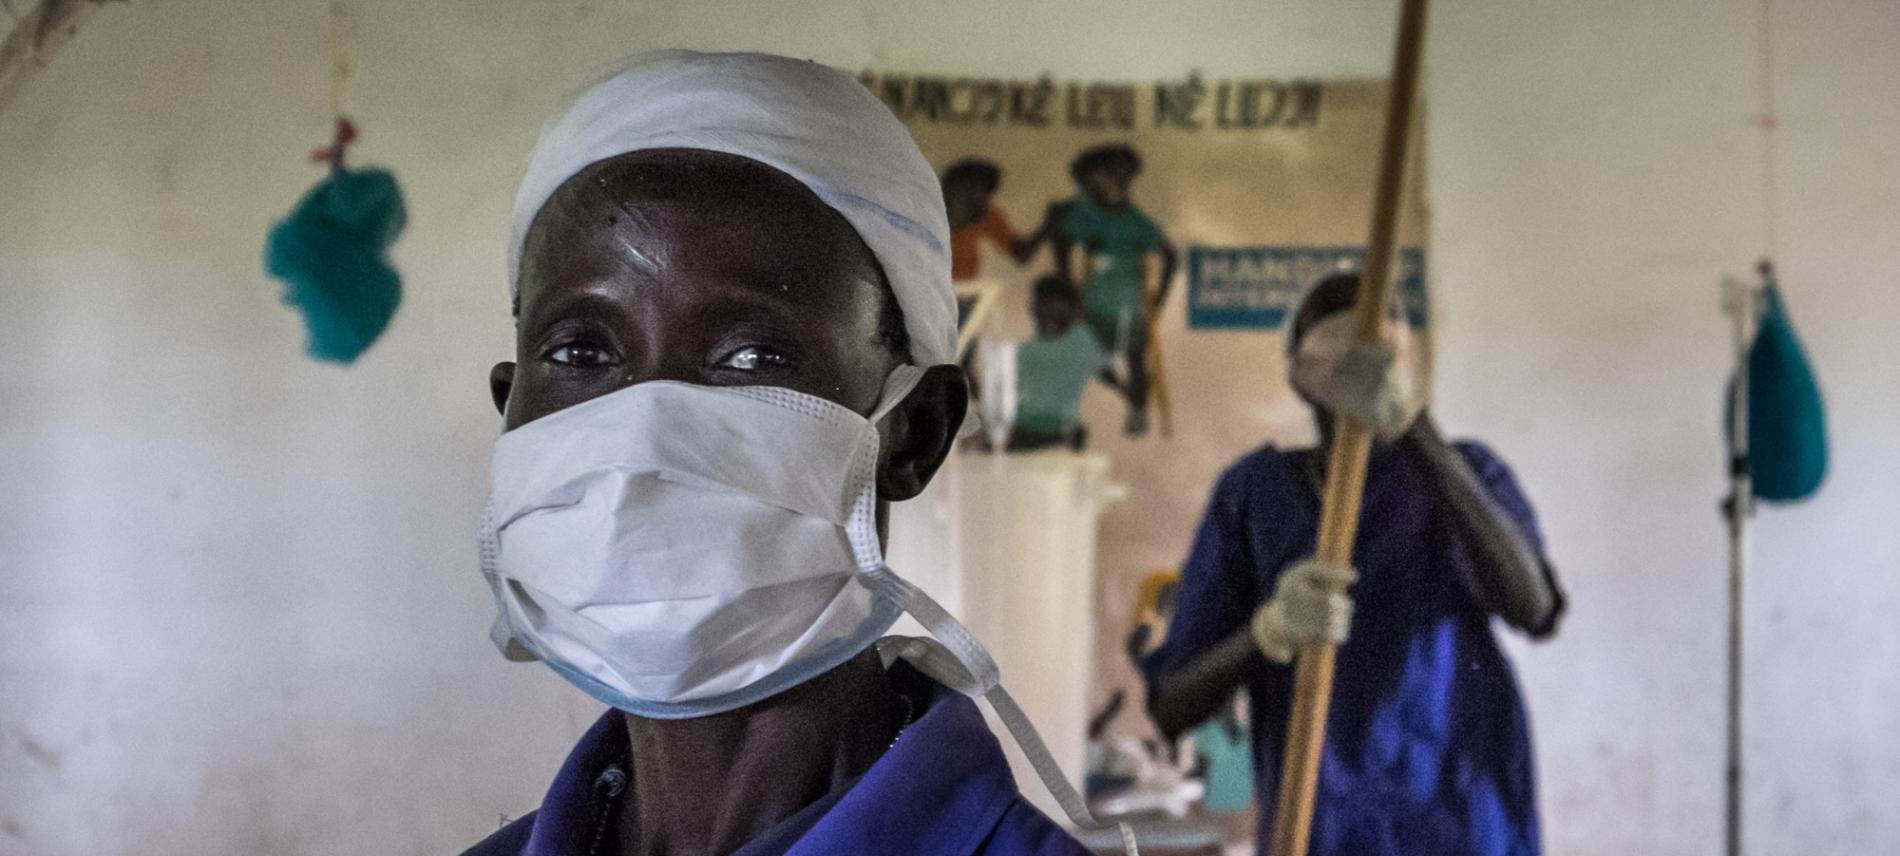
[{"left": 1431, "top": 2, "right": 1900, "bottom": 854}]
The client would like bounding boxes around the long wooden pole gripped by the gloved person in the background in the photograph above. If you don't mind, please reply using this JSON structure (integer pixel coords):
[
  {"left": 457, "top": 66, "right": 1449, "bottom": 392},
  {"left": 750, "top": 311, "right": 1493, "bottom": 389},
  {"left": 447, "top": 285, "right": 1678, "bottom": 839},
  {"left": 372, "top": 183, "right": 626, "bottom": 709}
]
[{"left": 1273, "top": 0, "right": 1427, "bottom": 856}]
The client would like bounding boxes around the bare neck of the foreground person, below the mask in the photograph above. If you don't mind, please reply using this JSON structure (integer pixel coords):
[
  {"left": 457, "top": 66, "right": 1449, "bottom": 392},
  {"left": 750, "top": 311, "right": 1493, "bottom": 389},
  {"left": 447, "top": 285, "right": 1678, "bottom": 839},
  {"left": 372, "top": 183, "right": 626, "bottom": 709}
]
[{"left": 618, "top": 649, "right": 910, "bottom": 856}]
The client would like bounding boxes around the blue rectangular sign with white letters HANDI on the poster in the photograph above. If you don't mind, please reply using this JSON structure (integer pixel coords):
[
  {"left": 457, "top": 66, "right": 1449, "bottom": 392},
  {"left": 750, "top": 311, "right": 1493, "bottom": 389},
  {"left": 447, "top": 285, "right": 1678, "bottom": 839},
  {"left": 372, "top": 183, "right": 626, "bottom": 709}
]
[{"left": 1188, "top": 247, "right": 1425, "bottom": 330}]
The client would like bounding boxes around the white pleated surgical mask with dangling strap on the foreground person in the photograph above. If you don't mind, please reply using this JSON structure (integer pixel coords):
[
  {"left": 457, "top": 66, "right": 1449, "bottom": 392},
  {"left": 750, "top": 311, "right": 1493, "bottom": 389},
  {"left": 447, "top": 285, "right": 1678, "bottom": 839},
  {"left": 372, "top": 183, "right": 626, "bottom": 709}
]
[{"left": 481, "top": 364, "right": 1132, "bottom": 845}]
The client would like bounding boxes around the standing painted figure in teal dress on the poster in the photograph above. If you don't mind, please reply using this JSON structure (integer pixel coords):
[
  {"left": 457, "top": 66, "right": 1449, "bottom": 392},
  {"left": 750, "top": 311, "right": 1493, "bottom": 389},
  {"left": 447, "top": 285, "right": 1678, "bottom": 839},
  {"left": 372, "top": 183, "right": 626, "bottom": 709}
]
[{"left": 1051, "top": 144, "right": 1178, "bottom": 437}]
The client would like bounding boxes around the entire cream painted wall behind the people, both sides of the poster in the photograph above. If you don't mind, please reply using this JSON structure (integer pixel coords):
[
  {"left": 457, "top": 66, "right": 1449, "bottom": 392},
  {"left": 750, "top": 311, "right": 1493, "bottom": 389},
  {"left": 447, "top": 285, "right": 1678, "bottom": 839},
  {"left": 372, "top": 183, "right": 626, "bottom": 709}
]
[{"left": 0, "top": 0, "right": 1900, "bottom": 856}]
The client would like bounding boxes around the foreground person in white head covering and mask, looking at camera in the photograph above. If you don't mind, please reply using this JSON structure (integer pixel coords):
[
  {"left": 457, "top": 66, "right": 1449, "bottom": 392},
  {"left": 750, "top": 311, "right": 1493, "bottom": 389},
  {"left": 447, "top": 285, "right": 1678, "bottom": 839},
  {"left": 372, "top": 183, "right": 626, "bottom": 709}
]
[{"left": 469, "top": 51, "right": 1117, "bottom": 856}]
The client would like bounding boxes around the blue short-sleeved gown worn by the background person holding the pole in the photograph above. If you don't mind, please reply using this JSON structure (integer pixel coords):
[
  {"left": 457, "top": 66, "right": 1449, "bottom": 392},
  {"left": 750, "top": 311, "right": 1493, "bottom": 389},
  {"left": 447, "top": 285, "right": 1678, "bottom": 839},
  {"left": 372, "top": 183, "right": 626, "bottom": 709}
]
[{"left": 1144, "top": 442, "right": 1549, "bottom": 856}]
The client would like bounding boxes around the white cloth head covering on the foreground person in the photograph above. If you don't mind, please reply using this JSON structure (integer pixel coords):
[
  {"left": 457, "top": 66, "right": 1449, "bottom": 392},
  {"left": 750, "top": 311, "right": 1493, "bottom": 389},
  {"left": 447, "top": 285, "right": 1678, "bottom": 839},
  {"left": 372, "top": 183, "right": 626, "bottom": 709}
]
[{"left": 507, "top": 51, "right": 958, "bottom": 366}]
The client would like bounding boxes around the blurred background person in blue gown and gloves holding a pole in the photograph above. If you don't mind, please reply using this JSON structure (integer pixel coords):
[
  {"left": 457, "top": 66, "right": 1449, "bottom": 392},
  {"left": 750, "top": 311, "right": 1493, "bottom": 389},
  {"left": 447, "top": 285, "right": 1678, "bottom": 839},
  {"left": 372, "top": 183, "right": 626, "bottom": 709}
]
[{"left": 1146, "top": 275, "right": 1564, "bottom": 856}]
